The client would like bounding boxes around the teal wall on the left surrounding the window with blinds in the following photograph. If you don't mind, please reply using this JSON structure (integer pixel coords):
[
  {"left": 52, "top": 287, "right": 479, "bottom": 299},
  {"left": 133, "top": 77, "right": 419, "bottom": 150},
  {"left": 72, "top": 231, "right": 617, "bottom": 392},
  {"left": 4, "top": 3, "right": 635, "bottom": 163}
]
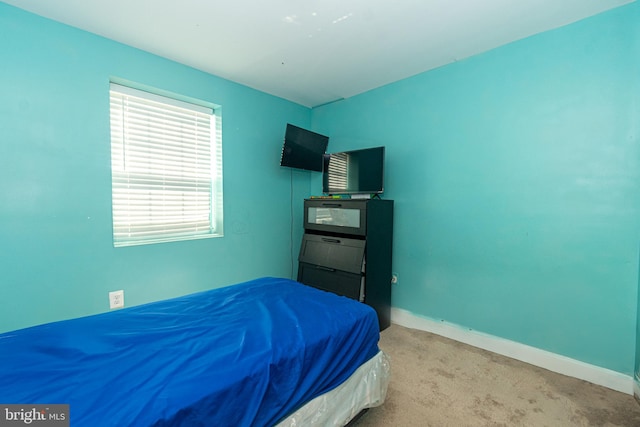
[{"left": 0, "top": 3, "right": 311, "bottom": 331}]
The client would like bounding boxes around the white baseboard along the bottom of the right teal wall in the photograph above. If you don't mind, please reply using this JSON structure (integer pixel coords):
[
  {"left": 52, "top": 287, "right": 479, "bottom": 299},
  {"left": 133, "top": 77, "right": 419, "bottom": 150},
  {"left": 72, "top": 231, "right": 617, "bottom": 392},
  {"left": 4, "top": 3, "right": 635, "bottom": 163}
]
[{"left": 391, "top": 308, "right": 640, "bottom": 396}]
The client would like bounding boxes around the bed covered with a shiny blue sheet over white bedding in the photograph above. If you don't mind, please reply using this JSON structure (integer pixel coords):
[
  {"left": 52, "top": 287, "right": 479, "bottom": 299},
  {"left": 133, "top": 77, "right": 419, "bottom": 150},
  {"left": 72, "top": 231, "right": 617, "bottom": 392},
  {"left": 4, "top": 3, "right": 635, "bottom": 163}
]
[{"left": 0, "top": 277, "right": 389, "bottom": 427}]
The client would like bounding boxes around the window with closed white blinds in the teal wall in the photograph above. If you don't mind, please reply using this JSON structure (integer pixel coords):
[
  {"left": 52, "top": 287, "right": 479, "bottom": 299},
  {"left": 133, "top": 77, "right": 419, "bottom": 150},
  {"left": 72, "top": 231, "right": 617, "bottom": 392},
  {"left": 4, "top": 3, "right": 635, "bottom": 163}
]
[{"left": 110, "top": 83, "right": 222, "bottom": 247}]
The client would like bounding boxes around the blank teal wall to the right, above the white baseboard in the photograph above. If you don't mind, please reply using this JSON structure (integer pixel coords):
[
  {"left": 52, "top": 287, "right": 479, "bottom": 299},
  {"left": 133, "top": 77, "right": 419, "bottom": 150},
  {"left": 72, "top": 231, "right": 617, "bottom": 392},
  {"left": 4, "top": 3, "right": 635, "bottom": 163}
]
[{"left": 312, "top": 3, "right": 640, "bottom": 375}]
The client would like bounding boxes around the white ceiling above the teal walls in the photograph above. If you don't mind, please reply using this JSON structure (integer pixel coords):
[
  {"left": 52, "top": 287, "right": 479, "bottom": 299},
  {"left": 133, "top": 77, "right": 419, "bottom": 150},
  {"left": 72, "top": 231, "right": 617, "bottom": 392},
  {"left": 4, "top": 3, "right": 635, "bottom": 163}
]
[{"left": 3, "top": 0, "right": 634, "bottom": 107}]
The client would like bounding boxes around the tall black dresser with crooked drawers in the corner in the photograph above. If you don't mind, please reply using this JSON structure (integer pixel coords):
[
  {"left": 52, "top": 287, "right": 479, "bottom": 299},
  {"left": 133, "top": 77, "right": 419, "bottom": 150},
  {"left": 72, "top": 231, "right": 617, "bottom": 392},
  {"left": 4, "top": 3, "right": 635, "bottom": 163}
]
[{"left": 298, "top": 199, "right": 393, "bottom": 330}]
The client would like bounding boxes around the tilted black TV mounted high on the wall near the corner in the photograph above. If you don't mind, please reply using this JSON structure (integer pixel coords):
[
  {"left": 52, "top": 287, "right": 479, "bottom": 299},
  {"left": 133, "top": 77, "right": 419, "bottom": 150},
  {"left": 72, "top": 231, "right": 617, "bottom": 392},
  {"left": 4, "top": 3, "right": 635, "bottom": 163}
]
[{"left": 280, "top": 123, "right": 329, "bottom": 172}]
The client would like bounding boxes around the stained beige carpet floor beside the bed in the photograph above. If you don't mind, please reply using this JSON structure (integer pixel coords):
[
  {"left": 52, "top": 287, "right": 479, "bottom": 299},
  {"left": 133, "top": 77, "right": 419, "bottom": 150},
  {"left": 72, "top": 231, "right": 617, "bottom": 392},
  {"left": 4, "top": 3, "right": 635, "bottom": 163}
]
[{"left": 355, "top": 325, "right": 640, "bottom": 427}]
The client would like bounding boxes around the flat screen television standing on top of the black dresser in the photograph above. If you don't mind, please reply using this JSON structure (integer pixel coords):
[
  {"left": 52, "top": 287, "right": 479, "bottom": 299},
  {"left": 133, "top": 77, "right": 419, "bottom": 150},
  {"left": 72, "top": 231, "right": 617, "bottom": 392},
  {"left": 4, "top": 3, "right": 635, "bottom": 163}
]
[{"left": 322, "top": 147, "right": 384, "bottom": 194}]
